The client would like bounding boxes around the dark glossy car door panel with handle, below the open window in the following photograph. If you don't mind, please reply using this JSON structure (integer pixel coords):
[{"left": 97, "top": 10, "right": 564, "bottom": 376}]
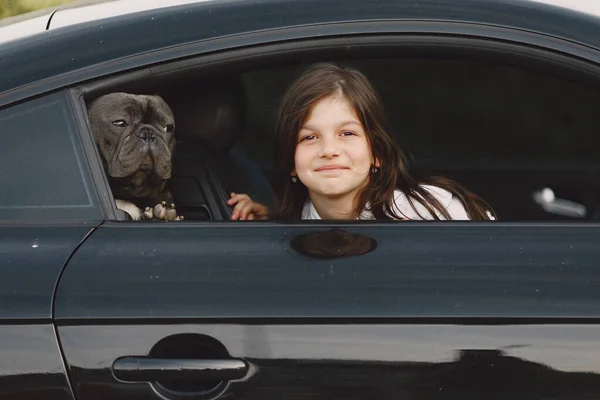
[{"left": 56, "top": 222, "right": 600, "bottom": 400}]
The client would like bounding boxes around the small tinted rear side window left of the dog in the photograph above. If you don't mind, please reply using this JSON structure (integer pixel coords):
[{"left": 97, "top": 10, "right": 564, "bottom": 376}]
[{"left": 0, "top": 93, "right": 102, "bottom": 222}]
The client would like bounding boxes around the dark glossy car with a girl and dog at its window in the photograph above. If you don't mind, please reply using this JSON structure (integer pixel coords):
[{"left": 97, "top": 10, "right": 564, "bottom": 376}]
[{"left": 0, "top": 0, "right": 600, "bottom": 400}]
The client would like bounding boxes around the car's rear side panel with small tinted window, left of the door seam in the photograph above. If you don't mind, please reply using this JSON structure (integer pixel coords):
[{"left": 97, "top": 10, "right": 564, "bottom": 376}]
[{"left": 0, "top": 93, "right": 102, "bottom": 400}]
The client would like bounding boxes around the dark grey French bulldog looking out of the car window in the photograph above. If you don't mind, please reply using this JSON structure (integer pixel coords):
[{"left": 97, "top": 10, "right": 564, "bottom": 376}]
[{"left": 88, "top": 93, "right": 181, "bottom": 220}]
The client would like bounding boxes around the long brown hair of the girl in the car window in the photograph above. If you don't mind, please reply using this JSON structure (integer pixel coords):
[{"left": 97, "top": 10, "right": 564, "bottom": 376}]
[{"left": 271, "top": 63, "right": 493, "bottom": 220}]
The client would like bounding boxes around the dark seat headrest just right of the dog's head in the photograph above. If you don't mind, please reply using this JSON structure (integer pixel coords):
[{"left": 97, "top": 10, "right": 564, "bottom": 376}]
[{"left": 161, "top": 76, "right": 245, "bottom": 153}]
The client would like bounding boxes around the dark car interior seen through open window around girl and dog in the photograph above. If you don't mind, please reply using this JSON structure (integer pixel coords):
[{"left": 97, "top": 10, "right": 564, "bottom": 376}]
[{"left": 82, "top": 39, "right": 600, "bottom": 221}]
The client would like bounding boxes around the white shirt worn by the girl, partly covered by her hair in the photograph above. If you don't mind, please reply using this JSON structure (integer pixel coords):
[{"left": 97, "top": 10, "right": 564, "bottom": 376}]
[{"left": 302, "top": 185, "right": 476, "bottom": 220}]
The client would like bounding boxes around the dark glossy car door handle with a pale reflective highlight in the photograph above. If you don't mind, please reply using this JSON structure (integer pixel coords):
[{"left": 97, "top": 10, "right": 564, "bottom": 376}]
[{"left": 113, "top": 356, "right": 248, "bottom": 382}]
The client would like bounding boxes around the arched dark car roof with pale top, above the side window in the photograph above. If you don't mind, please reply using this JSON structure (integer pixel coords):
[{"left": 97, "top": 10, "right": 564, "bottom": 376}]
[{"left": 0, "top": 0, "right": 600, "bottom": 106}]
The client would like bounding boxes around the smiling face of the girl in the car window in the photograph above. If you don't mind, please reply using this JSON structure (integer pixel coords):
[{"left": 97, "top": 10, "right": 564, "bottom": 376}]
[{"left": 292, "top": 95, "right": 379, "bottom": 203}]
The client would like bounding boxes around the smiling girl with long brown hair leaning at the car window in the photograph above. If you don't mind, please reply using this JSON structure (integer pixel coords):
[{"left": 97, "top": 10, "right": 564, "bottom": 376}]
[{"left": 228, "top": 63, "right": 495, "bottom": 220}]
